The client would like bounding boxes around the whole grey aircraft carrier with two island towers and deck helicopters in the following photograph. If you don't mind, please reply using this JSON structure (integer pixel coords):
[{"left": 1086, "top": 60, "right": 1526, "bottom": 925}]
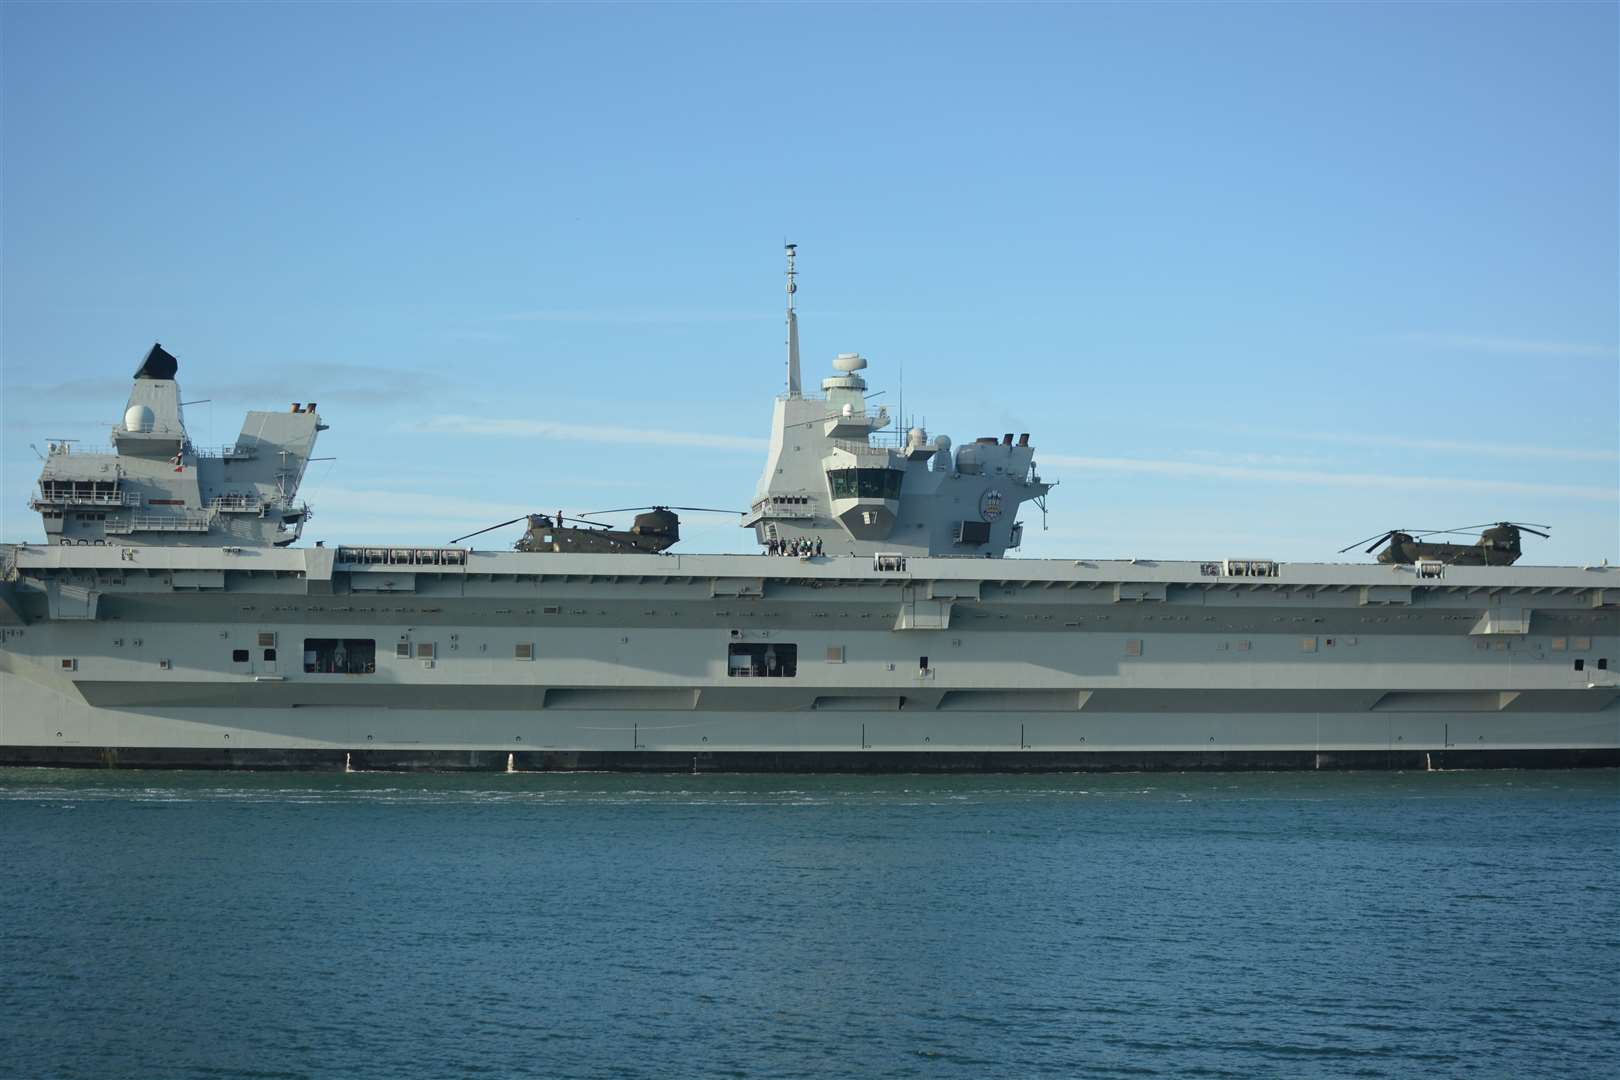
[{"left": 0, "top": 248, "right": 1620, "bottom": 771}]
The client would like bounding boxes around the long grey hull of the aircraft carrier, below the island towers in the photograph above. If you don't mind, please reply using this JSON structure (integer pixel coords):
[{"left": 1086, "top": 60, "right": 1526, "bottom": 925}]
[{"left": 0, "top": 547, "right": 1620, "bottom": 771}]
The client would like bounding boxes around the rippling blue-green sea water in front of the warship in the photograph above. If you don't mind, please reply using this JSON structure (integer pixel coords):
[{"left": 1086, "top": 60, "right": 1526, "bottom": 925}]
[{"left": 0, "top": 771, "right": 1620, "bottom": 1078}]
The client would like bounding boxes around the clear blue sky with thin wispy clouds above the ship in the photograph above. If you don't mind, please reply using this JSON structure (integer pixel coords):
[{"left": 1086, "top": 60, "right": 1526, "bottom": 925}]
[{"left": 0, "top": 3, "right": 1620, "bottom": 563}]
